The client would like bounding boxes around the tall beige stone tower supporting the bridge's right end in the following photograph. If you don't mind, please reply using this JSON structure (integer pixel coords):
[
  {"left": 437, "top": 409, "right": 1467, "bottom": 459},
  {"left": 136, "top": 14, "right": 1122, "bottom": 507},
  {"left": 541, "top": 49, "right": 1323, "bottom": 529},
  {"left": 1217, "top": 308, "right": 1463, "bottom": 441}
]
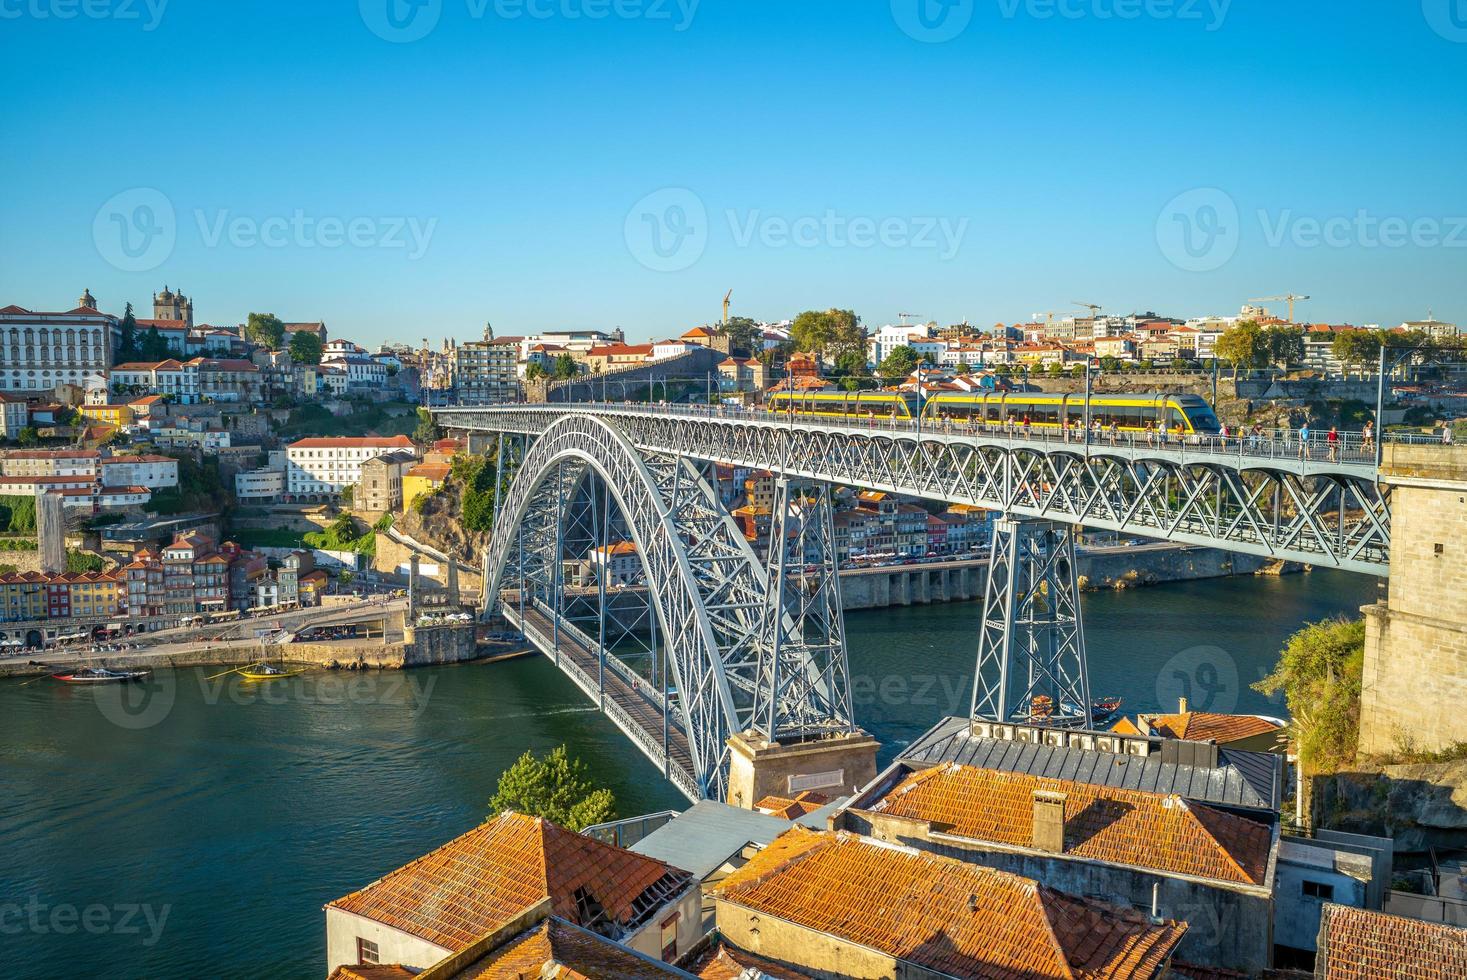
[{"left": 1360, "top": 443, "right": 1467, "bottom": 754}]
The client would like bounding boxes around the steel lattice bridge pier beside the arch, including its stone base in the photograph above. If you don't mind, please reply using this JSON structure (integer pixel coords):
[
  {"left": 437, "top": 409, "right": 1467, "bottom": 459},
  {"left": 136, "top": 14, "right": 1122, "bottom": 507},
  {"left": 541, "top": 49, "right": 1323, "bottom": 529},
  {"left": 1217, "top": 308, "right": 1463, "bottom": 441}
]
[{"left": 728, "top": 475, "right": 877, "bottom": 808}]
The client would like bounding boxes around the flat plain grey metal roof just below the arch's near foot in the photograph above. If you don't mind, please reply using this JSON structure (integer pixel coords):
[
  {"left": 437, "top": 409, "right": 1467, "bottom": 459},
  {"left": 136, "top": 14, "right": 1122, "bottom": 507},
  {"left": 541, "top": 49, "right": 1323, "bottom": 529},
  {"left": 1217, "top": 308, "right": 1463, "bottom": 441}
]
[{"left": 629, "top": 798, "right": 845, "bottom": 880}]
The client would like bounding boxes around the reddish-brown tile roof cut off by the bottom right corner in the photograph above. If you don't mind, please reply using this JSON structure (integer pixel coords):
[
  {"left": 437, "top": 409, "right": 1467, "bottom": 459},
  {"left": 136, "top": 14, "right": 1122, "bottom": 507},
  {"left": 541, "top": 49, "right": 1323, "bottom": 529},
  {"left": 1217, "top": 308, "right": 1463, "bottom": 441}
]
[{"left": 1314, "top": 904, "right": 1467, "bottom": 980}]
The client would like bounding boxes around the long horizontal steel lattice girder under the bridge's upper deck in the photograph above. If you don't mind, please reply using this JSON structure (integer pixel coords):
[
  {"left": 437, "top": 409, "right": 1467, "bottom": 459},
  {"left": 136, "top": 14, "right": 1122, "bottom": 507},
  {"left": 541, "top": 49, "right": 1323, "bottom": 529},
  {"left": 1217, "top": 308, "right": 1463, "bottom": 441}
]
[{"left": 437, "top": 405, "right": 1391, "bottom": 575}]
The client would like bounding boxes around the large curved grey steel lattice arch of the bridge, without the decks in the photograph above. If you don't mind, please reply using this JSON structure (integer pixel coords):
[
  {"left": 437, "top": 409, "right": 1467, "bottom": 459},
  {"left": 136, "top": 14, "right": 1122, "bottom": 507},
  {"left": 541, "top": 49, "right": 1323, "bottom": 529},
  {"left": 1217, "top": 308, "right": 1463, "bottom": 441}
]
[{"left": 484, "top": 414, "right": 766, "bottom": 798}]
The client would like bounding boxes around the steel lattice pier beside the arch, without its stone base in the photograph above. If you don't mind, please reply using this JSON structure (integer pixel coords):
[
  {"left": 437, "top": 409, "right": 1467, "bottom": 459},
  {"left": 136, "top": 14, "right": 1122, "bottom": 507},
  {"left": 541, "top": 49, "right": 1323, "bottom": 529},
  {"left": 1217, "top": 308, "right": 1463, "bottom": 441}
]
[{"left": 753, "top": 477, "right": 855, "bottom": 742}]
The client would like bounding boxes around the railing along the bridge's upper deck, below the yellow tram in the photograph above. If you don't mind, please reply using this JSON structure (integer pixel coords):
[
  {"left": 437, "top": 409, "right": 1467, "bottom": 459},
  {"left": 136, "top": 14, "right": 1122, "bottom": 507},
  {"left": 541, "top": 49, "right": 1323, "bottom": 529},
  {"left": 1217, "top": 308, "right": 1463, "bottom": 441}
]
[{"left": 469, "top": 402, "right": 1408, "bottom": 467}]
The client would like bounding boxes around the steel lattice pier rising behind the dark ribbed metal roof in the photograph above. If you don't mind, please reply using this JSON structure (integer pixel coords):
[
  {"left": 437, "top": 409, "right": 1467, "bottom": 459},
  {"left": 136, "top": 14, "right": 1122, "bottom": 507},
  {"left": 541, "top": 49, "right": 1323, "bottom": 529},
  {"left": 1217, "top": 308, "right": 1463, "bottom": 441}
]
[{"left": 973, "top": 519, "right": 1090, "bottom": 728}]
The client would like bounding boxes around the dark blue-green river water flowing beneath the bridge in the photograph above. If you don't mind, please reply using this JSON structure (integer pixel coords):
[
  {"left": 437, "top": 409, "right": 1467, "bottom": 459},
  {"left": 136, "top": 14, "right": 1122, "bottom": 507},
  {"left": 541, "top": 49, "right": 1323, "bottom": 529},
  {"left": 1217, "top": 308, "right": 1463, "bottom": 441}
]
[{"left": 0, "top": 572, "right": 1376, "bottom": 980}]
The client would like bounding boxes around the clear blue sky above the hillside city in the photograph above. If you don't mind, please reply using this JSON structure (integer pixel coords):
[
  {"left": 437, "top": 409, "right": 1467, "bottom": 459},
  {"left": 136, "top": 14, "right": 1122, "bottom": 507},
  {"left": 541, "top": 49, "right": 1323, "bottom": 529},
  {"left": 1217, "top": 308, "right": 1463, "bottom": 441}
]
[{"left": 0, "top": 0, "right": 1467, "bottom": 345}]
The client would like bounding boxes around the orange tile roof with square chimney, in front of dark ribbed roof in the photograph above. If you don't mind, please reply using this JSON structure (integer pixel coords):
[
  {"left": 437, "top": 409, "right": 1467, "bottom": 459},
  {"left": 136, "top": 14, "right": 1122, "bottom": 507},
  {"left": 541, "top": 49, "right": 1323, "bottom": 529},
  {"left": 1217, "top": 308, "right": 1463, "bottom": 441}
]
[{"left": 871, "top": 764, "right": 1273, "bottom": 885}]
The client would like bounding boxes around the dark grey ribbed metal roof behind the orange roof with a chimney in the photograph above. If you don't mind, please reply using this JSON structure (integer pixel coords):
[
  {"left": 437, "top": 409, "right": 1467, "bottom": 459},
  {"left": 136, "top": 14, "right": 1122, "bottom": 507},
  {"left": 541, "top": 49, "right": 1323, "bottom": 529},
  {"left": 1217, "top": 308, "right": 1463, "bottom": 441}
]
[{"left": 891, "top": 717, "right": 1284, "bottom": 809}]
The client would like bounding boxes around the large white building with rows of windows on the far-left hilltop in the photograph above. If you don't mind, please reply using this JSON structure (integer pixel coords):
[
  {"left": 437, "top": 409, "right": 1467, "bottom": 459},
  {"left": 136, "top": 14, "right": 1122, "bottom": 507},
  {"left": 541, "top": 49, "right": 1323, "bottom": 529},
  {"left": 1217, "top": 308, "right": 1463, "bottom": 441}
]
[{"left": 0, "top": 292, "right": 117, "bottom": 392}]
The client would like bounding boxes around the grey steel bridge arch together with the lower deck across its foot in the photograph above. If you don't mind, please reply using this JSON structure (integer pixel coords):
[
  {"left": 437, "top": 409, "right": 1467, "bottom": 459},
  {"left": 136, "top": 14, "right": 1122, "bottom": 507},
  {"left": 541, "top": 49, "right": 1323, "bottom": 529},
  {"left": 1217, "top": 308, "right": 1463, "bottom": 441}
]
[{"left": 486, "top": 412, "right": 767, "bottom": 798}]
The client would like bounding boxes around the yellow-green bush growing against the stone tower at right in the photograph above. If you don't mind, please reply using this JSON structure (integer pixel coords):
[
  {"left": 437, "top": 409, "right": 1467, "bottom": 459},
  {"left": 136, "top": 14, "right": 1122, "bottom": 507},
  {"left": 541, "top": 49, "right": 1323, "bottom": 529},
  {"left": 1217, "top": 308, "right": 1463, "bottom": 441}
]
[{"left": 1253, "top": 619, "right": 1366, "bottom": 775}]
